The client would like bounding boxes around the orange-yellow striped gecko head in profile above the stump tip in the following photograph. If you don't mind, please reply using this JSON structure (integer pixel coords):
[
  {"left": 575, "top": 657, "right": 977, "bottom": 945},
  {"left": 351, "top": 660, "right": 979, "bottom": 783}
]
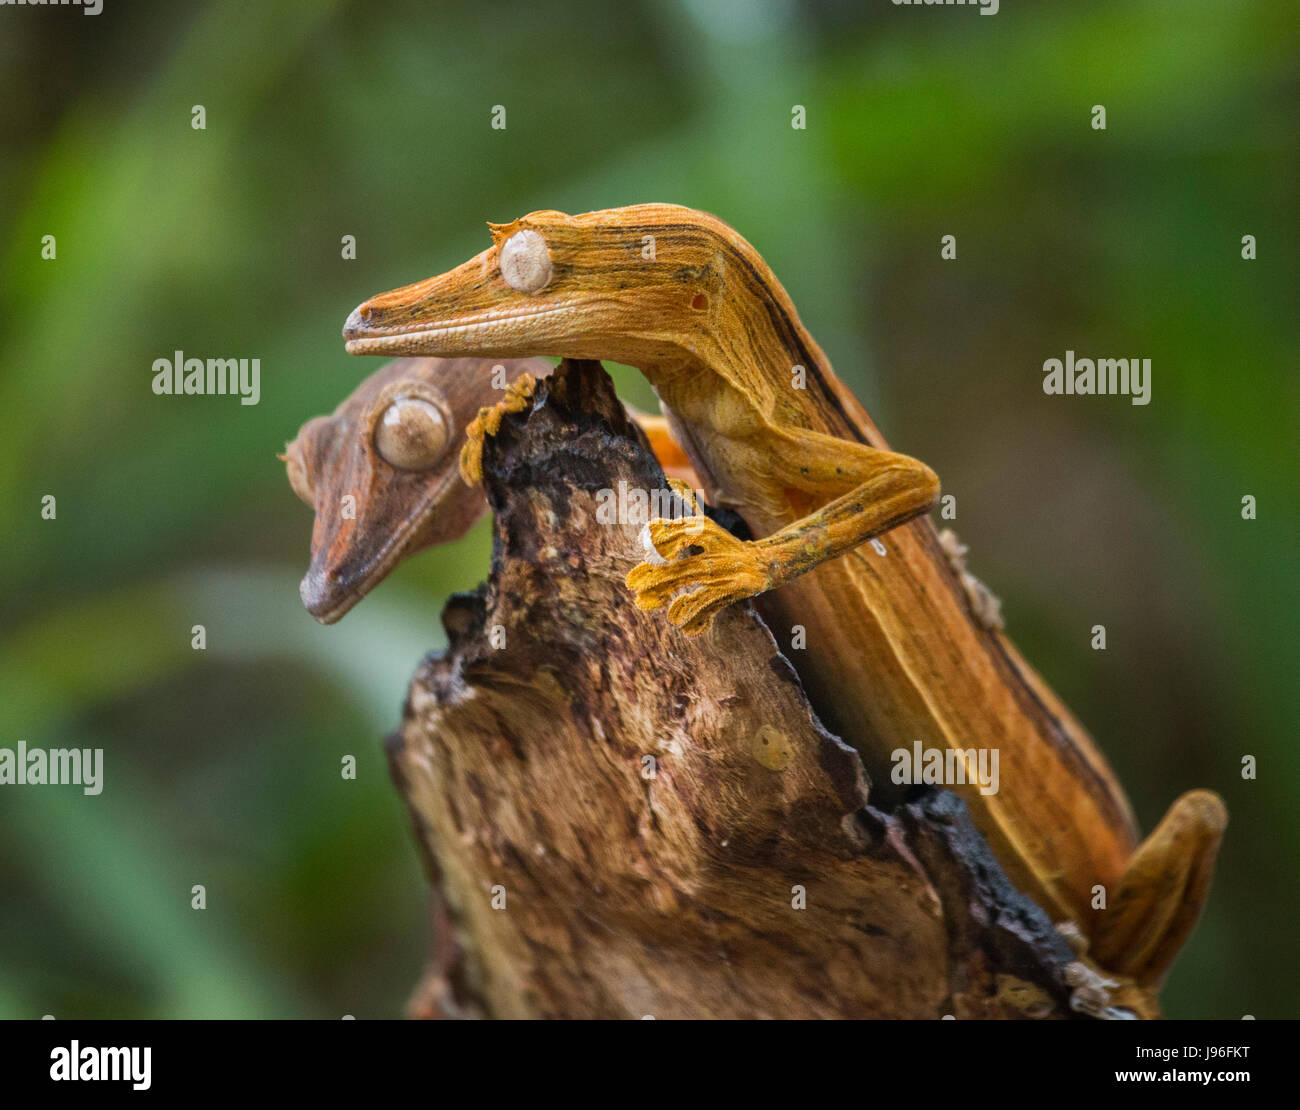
[{"left": 343, "top": 204, "right": 744, "bottom": 363}]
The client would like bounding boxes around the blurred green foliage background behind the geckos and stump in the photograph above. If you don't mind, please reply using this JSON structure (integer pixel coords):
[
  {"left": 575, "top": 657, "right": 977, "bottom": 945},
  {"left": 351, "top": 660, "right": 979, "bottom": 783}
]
[{"left": 0, "top": 0, "right": 1300, "bottom": 1018}]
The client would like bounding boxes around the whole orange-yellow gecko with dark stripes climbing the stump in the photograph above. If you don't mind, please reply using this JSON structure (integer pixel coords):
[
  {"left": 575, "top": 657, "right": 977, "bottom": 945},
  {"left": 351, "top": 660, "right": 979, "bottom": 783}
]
[{"left": 343, "top": 204, "right": 1226, "bottom": 987}]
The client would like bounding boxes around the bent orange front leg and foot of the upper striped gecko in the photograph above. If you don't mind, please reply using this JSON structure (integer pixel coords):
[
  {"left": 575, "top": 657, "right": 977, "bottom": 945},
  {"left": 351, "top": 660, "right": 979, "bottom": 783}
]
[{"left": 627, "top": 428, "right": 939, "bottom": 636}]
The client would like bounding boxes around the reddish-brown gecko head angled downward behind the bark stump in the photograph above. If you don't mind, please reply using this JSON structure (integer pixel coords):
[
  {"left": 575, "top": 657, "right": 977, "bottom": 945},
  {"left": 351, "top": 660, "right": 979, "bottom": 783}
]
[{"left": 281, "top": 359, "right": 551, "bottom": 624}]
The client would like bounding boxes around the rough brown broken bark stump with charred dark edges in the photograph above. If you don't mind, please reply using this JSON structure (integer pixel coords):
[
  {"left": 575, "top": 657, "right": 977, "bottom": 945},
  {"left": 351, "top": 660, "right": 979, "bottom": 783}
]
[{"left": 389, "top": 363, "right": 1092, "bottom": 1018}]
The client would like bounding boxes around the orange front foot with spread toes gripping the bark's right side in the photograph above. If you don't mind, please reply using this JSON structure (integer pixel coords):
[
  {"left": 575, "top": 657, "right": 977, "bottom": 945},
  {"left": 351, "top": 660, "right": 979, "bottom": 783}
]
[{"left": 627, "top": 516, "right": 772, "bottom": 636}]
